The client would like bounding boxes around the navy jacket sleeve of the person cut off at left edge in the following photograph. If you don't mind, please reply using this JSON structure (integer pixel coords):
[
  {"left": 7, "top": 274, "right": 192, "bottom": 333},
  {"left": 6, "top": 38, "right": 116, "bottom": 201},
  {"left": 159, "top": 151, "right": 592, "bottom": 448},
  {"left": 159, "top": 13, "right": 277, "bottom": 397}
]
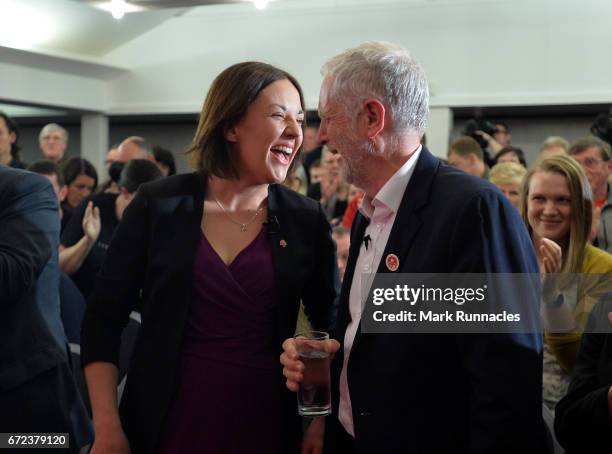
[{"left": 0, "top": 173, "right": 59, "bottom": 308}]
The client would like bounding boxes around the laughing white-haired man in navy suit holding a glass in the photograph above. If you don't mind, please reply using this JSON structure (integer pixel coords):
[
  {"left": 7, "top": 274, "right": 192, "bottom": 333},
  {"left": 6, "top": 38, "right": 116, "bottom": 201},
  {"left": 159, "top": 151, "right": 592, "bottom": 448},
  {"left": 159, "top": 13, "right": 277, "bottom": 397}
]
[{"left": 281, "top": 43, "right": 544, "bottom": 454}]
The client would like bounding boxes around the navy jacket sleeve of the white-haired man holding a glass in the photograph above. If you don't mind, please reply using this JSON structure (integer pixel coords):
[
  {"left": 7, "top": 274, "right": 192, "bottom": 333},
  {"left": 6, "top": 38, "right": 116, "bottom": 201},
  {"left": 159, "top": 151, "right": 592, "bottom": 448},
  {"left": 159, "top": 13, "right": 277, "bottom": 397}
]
[{"left": 449, "top": 189, "right": 544, "bottom": 453}]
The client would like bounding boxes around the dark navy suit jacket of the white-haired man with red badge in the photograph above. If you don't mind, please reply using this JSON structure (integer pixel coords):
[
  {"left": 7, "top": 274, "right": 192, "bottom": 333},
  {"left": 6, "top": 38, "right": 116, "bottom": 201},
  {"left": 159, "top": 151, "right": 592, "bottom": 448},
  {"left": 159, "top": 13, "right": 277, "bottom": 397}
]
[{"left": 332, "top": 148, "right": 544, "bottom": 454}]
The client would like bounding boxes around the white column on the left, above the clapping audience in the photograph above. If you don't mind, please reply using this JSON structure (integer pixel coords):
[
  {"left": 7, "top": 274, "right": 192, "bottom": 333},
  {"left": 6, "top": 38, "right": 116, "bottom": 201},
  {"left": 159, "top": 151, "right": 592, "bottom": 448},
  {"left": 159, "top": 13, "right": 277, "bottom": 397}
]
[{"left": 81, "top": 114, "right": 108, "bottom": 182}]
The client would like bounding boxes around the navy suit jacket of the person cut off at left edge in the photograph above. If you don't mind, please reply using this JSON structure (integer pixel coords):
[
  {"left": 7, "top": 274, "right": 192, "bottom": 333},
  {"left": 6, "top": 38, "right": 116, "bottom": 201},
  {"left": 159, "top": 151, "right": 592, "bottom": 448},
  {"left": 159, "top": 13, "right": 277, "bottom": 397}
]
[{"left": 0, "top": 166, "right": 68, "bottom": 390}]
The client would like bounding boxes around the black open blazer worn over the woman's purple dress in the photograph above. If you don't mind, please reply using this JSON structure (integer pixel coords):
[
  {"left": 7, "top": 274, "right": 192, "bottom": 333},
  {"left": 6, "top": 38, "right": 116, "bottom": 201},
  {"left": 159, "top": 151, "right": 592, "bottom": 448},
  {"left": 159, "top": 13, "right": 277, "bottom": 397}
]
[{"left": 81, "top": 173, "right": 337, "bottom": 453}]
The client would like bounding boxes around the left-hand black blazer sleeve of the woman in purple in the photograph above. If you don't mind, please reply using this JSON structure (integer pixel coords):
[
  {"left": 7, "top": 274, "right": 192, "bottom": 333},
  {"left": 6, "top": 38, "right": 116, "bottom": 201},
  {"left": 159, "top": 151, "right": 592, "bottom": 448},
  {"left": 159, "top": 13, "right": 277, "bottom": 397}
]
[{"left": 81, "top": 187, "right": 148, "bottom": 365}]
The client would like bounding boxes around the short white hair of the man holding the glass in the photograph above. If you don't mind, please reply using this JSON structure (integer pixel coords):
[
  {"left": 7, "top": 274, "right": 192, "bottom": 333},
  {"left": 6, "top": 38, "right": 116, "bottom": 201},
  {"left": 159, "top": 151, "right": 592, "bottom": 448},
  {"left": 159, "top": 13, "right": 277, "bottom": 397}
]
[{"left": 321, "top": 42, "right": 429, "bottom": 135}]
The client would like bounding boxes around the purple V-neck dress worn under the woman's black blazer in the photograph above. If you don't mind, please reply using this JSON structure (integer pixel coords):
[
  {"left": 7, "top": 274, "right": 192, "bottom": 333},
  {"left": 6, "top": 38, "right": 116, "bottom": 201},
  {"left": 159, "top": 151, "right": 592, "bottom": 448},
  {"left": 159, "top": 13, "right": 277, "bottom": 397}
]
[{"left": 158, "top": 229, "right": 283, "bottom": 454}]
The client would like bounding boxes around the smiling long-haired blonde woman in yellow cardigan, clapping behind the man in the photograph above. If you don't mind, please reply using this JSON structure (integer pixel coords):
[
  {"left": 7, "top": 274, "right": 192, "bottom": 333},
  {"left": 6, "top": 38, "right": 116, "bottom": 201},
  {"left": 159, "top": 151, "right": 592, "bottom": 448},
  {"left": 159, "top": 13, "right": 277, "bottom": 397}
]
[{"left": 520, "top": 155, "right": 612, "bottom": 410}]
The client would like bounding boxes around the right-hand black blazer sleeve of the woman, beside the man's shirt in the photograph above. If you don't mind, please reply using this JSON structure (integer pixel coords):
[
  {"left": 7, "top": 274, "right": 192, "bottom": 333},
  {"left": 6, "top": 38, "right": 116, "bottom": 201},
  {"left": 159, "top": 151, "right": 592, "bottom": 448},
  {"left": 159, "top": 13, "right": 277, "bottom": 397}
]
[{"left": 302, "top": 205, "right": 339, "bottom": 331}]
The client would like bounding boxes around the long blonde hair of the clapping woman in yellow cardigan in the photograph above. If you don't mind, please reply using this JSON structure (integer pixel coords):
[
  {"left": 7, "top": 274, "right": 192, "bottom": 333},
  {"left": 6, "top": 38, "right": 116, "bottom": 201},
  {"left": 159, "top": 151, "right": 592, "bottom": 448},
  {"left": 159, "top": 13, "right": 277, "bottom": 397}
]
[{"left": 519, "top": 155, "right": 593, "bottom": 273}]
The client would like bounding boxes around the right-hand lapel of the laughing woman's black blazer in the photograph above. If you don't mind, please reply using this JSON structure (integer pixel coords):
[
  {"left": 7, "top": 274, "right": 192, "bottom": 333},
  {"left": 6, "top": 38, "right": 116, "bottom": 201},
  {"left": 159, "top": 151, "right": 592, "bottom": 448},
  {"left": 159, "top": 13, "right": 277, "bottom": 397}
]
[{"left": 265, "top": 184, "right": 293, "bottom": 341}]
